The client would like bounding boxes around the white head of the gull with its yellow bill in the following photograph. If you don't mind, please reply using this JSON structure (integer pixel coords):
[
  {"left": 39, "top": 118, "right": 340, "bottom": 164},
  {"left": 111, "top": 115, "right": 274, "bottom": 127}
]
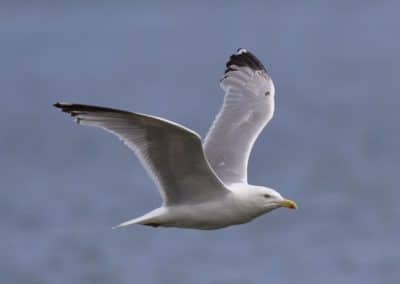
[{"left": 253, "top": 186, "right": 297, "bottom": 212}]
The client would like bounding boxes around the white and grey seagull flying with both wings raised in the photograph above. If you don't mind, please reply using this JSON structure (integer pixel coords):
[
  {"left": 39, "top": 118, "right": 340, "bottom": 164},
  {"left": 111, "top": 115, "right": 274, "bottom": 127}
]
[{"left": 54, "top": 48, "right": 297, "bottom": 230}]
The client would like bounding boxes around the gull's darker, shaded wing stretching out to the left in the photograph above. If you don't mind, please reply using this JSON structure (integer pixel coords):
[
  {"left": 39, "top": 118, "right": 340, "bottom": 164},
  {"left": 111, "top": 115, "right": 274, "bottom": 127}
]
[{"left": 54, "top": 103, "right": 228, "bottom": 205}]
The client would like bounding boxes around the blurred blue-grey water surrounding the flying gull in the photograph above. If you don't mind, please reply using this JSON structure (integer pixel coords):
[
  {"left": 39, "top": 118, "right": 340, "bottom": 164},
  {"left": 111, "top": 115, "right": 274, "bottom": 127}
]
[{"left": 0, "top": 1, "right": 400, "bottom": 284}]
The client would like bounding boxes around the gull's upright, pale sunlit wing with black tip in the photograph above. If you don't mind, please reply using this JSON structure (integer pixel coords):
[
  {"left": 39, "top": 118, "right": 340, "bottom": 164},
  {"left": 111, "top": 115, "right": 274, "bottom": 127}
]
[{"left": 204, "top": 49, "right": 275, "bottom": 184}]
